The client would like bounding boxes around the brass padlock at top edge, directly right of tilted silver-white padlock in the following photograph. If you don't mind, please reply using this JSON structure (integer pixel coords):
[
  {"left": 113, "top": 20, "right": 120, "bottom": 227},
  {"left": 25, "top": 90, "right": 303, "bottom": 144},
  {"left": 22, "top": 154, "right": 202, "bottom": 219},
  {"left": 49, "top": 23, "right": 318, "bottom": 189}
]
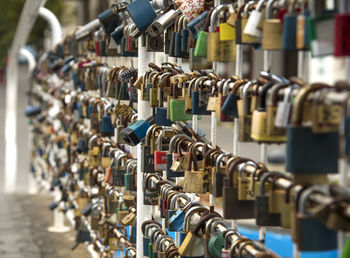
[{"left": 262, "top": 0, "right": 283, "bottom": 50}]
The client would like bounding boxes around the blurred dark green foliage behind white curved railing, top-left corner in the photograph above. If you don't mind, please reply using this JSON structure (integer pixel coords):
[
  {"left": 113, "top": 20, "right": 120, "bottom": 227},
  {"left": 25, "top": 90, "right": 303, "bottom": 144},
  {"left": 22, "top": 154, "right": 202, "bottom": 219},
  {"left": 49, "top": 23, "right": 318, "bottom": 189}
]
[{"left": 0, "top": 0, "right": 64, "bottom": 68}]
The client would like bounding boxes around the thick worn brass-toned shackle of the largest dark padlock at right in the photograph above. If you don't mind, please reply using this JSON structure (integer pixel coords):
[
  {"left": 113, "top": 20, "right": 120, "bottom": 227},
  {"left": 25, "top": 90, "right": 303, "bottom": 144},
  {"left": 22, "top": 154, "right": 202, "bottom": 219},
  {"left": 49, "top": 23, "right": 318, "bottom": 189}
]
[{"left": 291, "top": 83, "right": 331, "bottom": 125}]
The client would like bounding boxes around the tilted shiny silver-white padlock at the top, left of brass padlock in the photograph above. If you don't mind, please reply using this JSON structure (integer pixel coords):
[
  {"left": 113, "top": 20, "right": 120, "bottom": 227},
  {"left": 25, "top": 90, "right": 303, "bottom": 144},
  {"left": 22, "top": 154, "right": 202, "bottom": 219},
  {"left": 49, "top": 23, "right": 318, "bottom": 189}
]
[{"left": 243, "top": 0, "right": 266, "bottom": 38}]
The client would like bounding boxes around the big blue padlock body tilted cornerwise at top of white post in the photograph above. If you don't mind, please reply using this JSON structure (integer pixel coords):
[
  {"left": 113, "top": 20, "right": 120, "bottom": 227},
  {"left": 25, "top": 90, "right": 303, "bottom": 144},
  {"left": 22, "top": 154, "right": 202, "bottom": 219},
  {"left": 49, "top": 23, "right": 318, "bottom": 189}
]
[{"left": 126, "top": 0, "right": 157, "bottom": 31}]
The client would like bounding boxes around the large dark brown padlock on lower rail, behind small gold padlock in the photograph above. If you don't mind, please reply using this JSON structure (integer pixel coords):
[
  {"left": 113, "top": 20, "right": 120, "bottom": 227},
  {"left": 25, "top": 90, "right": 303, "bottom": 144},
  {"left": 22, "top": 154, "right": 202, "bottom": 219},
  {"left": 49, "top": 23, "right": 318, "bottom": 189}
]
[{"left": 223, "top": 158, "right": 255, "bottom": 219}]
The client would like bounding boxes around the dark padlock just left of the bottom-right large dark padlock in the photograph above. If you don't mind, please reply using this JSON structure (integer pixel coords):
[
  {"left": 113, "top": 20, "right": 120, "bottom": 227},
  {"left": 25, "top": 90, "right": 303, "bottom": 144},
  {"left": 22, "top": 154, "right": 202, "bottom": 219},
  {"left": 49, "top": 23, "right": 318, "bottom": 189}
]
[{"left": 255, "top": 171, "right": 287, "bottom": 226}]
